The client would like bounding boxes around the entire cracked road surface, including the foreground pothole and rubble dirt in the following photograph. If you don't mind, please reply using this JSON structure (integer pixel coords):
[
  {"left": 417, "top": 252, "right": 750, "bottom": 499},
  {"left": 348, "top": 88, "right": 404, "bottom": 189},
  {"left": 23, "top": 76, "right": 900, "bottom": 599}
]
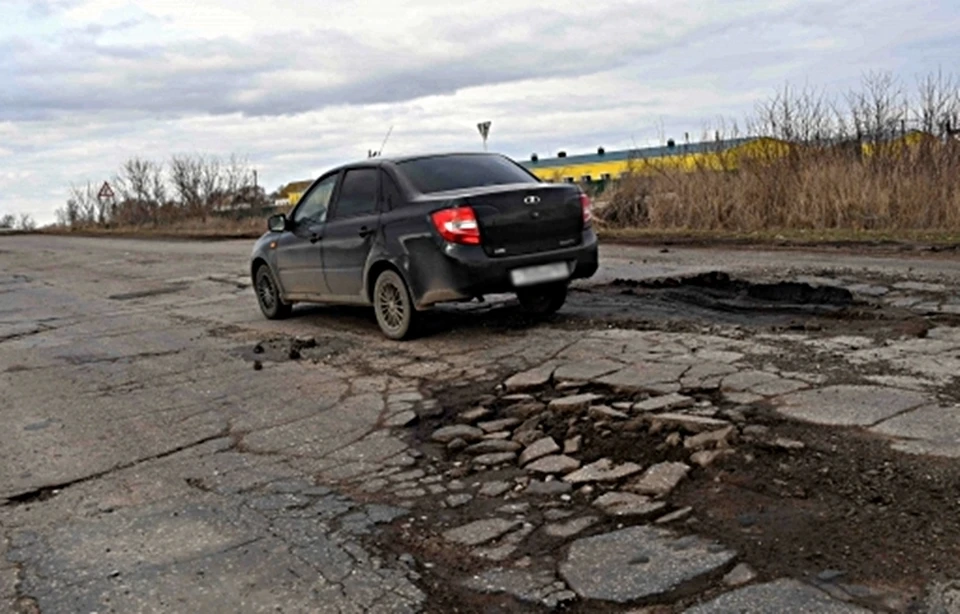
[{"left": 0, "top": 236, "right": 960, "bottom": 614}]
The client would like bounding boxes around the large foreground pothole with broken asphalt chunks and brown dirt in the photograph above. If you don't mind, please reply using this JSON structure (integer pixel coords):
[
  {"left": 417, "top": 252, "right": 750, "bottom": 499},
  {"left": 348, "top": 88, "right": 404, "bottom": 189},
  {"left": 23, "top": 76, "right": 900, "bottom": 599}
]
[{"left": 348, "top": 372, "right": 960, "bottom": 612}]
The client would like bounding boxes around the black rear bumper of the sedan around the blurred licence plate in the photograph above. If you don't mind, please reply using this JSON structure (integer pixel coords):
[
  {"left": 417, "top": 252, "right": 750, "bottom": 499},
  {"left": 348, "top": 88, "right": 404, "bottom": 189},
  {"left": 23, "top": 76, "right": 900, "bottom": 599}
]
[{"left": 409, "top": 229, "right": 599, "bottom": 309}]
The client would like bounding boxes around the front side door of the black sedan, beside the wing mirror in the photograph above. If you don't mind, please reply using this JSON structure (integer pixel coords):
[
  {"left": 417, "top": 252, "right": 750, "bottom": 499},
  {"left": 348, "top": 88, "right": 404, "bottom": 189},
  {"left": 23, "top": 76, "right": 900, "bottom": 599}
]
[{"left": 277, "top": 173, "right": 339, "bottom": 297}]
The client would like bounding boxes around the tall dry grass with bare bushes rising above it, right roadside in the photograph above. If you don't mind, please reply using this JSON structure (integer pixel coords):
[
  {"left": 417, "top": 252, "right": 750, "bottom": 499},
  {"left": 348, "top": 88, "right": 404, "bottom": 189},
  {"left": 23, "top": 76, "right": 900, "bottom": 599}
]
[{"left": 598, "top": 74, "right": 960, "bottom": 240}]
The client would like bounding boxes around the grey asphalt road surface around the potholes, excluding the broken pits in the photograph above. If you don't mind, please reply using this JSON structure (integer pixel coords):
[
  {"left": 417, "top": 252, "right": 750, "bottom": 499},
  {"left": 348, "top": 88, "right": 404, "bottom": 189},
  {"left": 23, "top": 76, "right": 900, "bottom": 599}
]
[{"left": 0, "top": 236, "right": 960, "bottom": 613}]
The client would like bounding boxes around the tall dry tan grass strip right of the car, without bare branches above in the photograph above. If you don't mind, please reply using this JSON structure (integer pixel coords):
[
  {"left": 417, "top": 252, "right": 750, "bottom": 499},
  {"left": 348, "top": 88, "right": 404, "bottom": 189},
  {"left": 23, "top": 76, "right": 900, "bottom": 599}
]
[{"left": 599, "top": 142, "right": 960, "bottom": 236}]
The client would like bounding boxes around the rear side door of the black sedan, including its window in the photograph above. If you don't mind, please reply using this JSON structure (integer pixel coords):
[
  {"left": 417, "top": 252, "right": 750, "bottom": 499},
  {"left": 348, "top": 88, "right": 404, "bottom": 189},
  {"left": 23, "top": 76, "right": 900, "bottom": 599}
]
[{"left": 321, "top": 167, "right": 380, "bottom": 301}]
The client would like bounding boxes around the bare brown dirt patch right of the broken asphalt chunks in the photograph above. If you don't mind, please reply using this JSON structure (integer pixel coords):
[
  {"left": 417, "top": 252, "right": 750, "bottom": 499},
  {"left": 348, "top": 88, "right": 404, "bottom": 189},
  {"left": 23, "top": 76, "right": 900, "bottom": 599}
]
[{"left": 671, "top": 418, "right": 960, "bottom": 605}]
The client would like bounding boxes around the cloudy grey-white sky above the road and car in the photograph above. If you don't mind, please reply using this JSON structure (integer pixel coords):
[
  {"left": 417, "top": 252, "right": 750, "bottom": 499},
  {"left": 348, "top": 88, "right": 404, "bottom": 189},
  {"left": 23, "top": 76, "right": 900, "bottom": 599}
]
[{"left": 0, "top": 0, "right": 960, "bottom": 223}]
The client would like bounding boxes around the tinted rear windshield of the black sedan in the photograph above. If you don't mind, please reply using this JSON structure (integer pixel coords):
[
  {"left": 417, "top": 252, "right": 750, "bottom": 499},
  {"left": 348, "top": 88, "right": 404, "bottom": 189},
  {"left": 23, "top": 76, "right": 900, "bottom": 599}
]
[{"left": 397, "top": 154, "right": 538, "bottom": 194}]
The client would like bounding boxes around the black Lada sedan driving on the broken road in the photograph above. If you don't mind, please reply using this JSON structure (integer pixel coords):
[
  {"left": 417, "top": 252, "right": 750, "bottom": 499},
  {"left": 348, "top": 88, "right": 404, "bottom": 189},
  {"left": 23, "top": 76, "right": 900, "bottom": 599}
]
[{"left": 250, "top": 153, "right": 598, "bottom": 339}]
